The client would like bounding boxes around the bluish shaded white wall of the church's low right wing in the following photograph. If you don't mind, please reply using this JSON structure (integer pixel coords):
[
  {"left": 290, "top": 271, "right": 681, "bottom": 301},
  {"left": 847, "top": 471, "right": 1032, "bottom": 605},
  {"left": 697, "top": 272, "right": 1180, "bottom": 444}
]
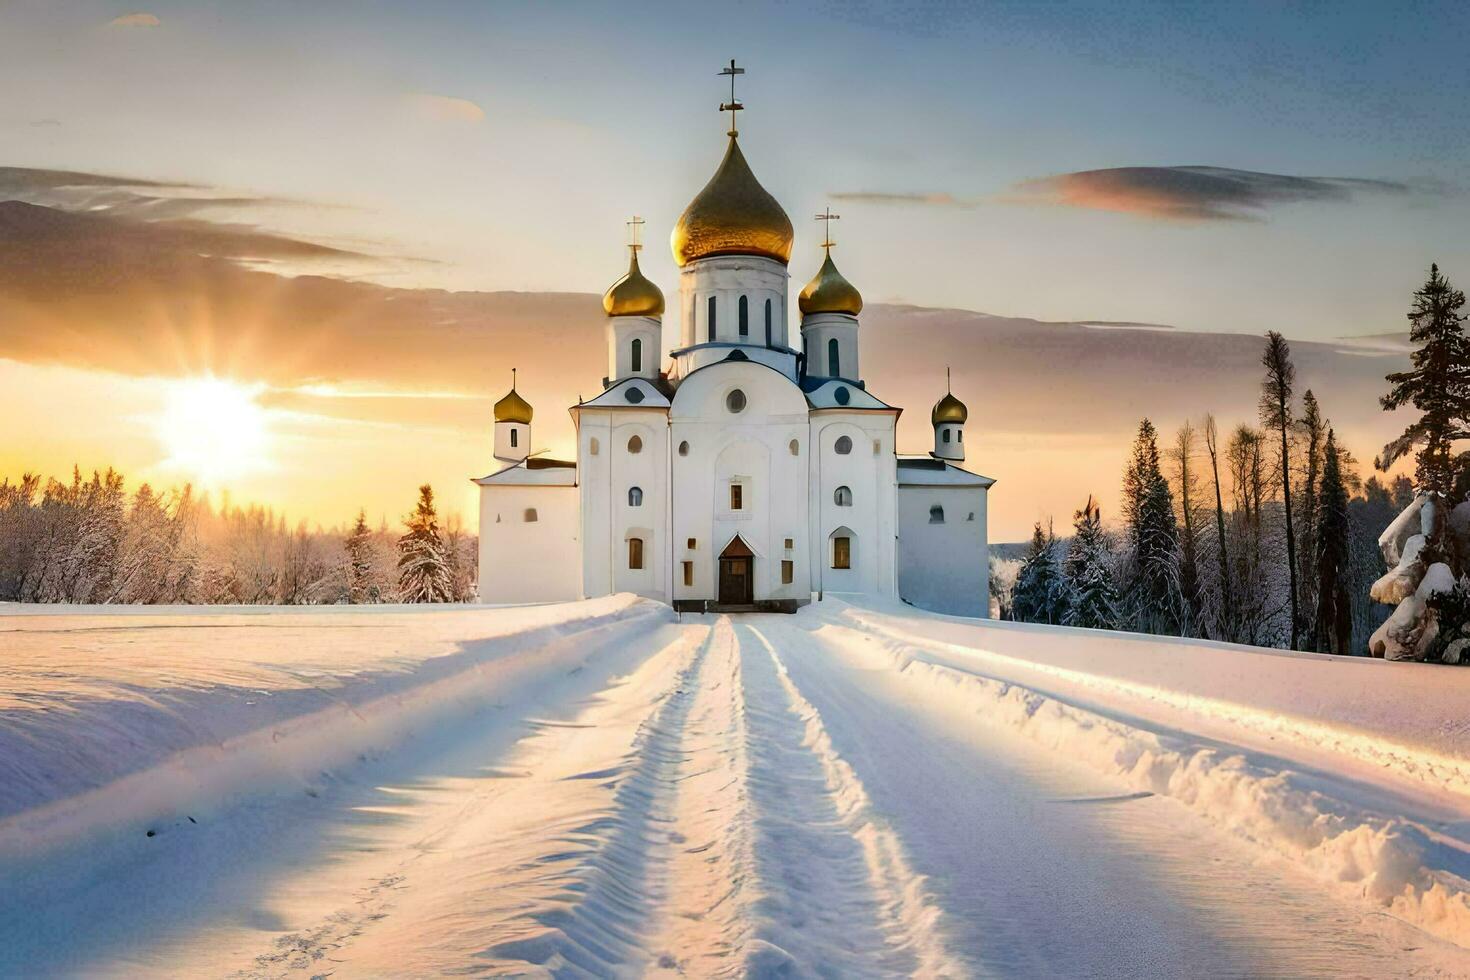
[{"left": 898, "top": 485, "right": 991, "bottom": 617}]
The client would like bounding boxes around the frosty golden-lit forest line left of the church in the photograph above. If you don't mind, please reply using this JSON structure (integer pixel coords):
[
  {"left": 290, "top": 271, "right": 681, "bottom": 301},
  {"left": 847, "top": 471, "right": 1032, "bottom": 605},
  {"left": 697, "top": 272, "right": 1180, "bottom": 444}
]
[{"left": 0, "top": 467, "right": 478, "bottom": 605}]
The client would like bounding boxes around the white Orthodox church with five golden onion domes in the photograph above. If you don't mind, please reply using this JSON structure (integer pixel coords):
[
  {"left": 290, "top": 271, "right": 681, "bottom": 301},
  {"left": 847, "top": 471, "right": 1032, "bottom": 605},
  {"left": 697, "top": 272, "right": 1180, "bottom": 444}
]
[{"left": 475, "top": 62, "right": 994, "bottom": 617}]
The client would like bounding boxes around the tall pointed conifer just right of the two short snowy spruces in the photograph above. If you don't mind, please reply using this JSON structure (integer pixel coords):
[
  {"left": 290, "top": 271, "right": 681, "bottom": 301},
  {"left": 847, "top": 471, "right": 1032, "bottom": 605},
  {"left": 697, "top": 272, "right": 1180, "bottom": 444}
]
[{"left": 1123, "top": 419, "right": 1183, "bottom": 636}]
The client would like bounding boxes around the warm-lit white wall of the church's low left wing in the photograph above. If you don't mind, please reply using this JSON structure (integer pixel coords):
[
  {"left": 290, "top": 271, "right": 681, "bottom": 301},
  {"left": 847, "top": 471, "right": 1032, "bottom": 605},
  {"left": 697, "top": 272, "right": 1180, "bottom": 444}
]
[{"left": 479, "top": 485, "right": 582, "bottom": 602}]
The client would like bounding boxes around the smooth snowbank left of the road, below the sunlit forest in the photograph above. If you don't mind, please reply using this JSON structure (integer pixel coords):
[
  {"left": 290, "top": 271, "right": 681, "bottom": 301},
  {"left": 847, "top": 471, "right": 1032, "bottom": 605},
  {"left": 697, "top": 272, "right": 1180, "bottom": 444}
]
[{"left": 0, "top": 595, "right": 672, "bottom": 857}]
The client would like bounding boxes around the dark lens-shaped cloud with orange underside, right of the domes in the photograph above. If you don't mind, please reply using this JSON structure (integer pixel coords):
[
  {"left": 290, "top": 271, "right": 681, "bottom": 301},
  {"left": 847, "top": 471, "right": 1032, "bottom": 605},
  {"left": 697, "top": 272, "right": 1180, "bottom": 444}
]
[{"left": 1014, "top": 166, "right": 1413, "bottom": 222}]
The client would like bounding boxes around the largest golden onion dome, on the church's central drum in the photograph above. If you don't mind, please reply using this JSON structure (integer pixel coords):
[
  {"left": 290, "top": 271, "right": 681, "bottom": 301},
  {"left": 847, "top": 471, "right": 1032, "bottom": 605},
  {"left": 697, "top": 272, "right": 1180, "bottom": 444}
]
[{"left": 669, "top": 135, "right": 792, "bottom": 267}]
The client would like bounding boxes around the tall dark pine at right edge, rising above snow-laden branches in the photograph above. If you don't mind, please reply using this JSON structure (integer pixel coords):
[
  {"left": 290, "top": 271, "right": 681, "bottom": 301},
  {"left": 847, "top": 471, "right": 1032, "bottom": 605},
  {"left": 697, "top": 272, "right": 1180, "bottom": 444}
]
[{"left": 1374, "top": 264, "right": 1470, "bottom": 494}]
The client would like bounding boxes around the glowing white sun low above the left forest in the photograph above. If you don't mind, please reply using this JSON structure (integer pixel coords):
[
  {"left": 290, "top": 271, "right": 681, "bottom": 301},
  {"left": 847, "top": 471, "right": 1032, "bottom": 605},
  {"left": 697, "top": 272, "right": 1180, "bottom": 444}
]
[{"left": 156, "top": 378, "right": 270, "bottom": 486}]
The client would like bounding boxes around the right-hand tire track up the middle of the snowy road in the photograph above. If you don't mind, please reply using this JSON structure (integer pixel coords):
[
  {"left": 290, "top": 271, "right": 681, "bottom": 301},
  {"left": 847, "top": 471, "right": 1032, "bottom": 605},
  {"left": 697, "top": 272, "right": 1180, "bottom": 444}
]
[{"left": 741, "top": 626, "right": 970, "bottom": 977}]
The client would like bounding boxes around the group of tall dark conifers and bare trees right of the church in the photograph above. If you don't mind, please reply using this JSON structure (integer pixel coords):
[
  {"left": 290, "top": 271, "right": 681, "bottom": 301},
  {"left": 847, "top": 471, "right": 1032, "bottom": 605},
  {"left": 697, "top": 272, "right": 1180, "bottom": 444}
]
[{"left": 997, "top": 266, "right": 1470, "bottom": 660}]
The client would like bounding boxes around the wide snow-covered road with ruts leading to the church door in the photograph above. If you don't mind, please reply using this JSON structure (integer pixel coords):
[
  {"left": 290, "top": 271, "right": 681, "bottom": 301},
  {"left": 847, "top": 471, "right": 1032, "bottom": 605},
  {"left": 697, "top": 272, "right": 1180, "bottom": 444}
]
[{"left": 0, "top": 611, "right": 1470, "bottom": 977}]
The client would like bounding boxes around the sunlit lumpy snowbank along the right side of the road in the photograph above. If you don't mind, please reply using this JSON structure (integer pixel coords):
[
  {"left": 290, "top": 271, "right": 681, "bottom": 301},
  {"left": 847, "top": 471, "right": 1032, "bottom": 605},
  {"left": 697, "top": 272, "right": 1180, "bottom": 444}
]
[{"left": 826, "top": 607, "right": 1470, "bottom": 946}]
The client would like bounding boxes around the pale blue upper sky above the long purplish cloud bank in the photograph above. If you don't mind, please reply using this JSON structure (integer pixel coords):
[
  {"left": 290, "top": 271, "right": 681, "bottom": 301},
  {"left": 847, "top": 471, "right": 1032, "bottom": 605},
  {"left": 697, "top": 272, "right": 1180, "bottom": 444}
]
[{"left": 0, "top": 0, "right": 1470, "bottom": 338}]
